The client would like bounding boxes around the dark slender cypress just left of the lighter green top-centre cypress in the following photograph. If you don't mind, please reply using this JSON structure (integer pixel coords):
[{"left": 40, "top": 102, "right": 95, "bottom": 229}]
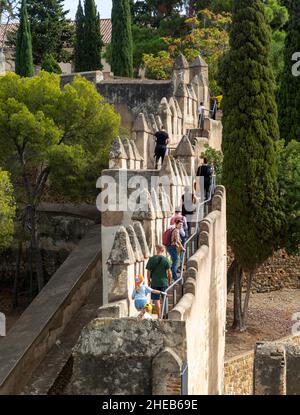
[{"left": 81, "top": 0, "right": 103, "bottom": 71}]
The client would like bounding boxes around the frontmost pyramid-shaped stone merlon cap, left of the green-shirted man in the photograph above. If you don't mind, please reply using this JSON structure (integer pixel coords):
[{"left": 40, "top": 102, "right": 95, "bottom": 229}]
[{"left": 107, "top": 226, "right": 135, "bottom": 265}]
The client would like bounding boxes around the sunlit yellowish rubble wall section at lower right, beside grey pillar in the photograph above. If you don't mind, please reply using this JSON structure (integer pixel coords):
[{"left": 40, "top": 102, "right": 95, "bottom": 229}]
[{"left": 224, "top": 351, "right": 254, "bottom": 395}]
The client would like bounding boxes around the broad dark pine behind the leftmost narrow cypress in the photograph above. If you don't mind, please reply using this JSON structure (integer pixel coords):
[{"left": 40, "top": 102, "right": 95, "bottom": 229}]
[{"left": 27, "top": 0, "right": 74, "bottom": 65}]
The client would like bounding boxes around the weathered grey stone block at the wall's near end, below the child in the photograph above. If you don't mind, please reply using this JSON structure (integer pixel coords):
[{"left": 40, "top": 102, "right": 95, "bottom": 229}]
[{"left": 68, "top": 318, "right": 186, "bottom": 395}]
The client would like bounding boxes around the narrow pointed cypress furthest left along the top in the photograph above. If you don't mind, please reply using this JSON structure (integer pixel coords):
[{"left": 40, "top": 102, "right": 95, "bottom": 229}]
[{"left": 16, "top": 0, "right": 34, "bottom": 77}]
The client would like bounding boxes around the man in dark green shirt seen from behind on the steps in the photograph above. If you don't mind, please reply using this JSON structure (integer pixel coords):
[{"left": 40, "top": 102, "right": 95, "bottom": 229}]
[{"left": 146, "top": 245, "right": 172, "bottom": 316}]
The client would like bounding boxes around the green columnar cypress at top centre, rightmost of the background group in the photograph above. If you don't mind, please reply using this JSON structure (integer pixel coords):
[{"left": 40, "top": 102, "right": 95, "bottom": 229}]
[{"left": 111, "top": 0, "right": 133, "bottom": 77}]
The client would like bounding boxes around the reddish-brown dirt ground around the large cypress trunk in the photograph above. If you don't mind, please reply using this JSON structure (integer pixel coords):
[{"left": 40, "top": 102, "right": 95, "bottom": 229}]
[{"left": 225, "top": 289, "right": 300, "bottom": 359}]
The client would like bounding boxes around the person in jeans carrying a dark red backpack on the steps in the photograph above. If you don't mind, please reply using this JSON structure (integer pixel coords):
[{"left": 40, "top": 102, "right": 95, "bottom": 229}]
[{"left": 164, "top": 219, "right": 185, "bottom": 281}]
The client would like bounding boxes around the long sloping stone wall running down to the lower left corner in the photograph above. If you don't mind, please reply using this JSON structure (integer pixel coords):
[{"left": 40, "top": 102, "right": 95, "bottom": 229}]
[{"left": 0, "top": 226, "right": 101, "bottom": 395}]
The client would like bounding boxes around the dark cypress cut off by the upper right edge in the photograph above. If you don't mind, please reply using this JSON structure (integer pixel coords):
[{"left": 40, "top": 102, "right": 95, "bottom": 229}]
[{"left": 278, "top": 0, "right": 300, "bottom": 141}]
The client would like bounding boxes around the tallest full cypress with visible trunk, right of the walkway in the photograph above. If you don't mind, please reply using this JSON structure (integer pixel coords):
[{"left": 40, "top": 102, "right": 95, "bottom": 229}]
[{"left": 220, "top": 0, "right": 282, "bottom": 330}]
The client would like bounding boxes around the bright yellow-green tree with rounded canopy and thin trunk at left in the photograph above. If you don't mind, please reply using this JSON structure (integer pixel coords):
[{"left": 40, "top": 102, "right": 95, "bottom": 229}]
[{"left": 0, "top": 71, "right": 120, "bottom": 290}]
